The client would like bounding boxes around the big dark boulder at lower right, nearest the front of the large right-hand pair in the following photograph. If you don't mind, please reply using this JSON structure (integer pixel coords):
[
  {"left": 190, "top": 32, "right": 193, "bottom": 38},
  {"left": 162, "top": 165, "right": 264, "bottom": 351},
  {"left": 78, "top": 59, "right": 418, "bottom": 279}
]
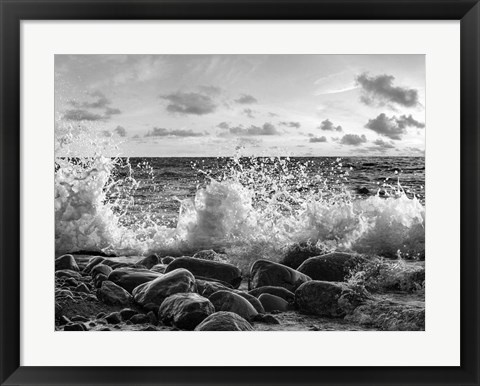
[{"left": 295, "top": 280, "right": 366, "bottom": 317}]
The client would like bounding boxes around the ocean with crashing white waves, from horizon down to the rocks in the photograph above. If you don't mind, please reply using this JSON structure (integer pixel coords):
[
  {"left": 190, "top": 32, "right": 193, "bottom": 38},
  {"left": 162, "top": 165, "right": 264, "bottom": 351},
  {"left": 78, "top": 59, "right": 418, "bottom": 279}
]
[{"left": 55, "top": 156, "right": 425, "bottom": 261}]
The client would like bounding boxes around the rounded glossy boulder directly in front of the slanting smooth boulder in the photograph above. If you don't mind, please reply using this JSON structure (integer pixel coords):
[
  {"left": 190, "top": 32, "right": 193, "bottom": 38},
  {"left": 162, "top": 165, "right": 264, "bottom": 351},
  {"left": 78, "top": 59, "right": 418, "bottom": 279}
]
[{"left": 158, "top": 293, "right": 215, "bottom": 330}]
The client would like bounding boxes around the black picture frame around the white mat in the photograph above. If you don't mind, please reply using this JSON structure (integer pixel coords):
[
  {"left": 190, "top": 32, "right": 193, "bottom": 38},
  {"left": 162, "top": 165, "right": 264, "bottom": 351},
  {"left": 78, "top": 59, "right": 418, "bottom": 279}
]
[{"left": 0, "top": 0, "right": 480, "bottom": 385}]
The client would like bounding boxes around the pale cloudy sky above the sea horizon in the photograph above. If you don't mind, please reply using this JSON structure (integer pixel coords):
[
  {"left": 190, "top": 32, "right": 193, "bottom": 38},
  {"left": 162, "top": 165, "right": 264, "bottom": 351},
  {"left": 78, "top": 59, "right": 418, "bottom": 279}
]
[{"left": 55, "top": 55, "right": 426, "bottom": 157}]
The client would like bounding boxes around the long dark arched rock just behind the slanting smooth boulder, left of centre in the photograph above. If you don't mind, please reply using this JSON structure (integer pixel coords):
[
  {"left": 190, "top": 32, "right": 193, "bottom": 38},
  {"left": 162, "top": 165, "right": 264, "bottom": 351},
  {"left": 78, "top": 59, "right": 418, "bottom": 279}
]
[{"left": 165, "top": 257, "right": 242, "bottom": 288}]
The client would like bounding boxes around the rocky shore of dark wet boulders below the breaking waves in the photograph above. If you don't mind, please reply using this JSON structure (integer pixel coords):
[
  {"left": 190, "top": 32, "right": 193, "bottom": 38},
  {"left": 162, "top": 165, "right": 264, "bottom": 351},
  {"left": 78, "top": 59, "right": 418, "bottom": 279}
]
[{"left": 55, "top": 247, "right": 425, "bottom": 331}]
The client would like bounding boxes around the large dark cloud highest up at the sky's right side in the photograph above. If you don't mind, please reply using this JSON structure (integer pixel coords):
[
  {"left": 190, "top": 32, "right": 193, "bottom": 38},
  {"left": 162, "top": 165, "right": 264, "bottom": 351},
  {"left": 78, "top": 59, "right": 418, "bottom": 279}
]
[{"left": 355, "top": 73, "right": 419, "bottom": 107}]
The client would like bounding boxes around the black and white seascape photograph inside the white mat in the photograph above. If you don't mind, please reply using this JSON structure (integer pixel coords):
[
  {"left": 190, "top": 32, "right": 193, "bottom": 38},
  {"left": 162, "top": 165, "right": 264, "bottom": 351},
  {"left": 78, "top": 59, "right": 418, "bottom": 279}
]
[{"left": 54, "top": 53, "right": 426, "bottom": 334}]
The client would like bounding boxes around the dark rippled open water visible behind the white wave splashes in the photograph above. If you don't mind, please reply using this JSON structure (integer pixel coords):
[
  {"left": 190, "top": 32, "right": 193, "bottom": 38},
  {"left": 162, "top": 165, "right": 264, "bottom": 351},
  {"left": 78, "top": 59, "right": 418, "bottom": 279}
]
[{"left": 113, "top": 157, "right": 425, "bottom": 226}]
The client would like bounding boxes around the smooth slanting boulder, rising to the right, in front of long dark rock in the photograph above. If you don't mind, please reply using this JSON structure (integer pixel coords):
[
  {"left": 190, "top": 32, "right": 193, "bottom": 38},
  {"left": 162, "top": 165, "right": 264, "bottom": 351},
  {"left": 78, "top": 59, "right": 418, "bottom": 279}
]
[{"left": 133, "top": 268, "right": 196, "bottom": 310}]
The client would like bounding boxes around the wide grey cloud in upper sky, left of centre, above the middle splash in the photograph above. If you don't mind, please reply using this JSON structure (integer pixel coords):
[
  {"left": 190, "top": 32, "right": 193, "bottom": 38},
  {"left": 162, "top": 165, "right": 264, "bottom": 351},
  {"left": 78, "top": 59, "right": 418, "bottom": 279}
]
[{"left": 160, "top": 92, "right": 217, "bottom": 115}]
